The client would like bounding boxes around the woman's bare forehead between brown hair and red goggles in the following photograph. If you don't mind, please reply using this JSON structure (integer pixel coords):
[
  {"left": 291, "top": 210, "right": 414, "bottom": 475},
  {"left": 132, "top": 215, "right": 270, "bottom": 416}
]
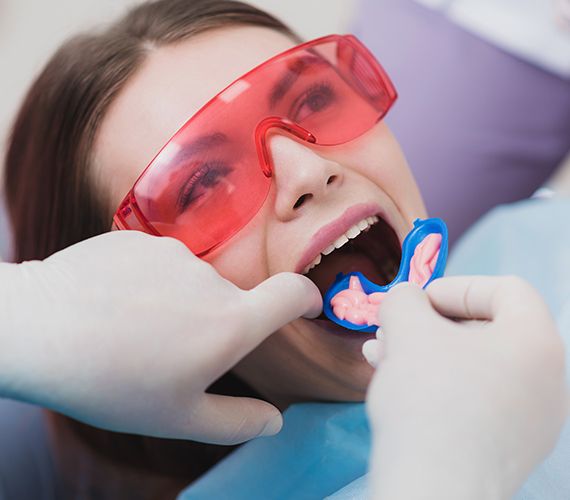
[{"left": 94, "top": 26, "right": 295, "bottom": 205}]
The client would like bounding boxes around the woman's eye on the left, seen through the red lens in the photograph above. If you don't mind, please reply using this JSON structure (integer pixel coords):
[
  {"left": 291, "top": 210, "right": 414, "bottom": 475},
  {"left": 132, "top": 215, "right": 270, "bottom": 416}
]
[{"left": 176, "top": 161, "right": 234, "bottom": 212}]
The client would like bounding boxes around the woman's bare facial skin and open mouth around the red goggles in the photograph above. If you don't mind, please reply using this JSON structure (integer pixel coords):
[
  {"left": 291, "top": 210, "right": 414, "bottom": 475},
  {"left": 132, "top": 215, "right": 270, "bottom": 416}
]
[{"left": 93, "top": 26, "right": 425, "bottom": 406}]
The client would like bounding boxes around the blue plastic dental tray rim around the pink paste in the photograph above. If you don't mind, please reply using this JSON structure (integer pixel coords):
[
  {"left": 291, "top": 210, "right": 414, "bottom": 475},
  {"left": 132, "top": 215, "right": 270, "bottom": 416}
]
[{"left": 323, "top": 218, "right": 448, "bottom": 333}]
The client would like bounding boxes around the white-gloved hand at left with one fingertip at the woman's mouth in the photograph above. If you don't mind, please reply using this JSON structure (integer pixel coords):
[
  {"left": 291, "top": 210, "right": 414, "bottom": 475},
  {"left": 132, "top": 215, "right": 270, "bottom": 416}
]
[{"left": 0, "top": 231, "right": 321, "bottom": 444}]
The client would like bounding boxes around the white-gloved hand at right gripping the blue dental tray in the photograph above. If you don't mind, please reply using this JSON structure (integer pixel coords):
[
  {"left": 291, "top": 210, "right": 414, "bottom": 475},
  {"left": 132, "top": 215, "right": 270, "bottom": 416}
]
[{"left": 366, "top": 277, "right": 567, "bottom": 500}]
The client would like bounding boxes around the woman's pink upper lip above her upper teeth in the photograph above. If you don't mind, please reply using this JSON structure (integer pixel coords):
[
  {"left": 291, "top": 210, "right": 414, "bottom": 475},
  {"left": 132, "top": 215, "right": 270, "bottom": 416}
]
[{"left": 295, "top": 203, "right": 385, "bottom": 273}]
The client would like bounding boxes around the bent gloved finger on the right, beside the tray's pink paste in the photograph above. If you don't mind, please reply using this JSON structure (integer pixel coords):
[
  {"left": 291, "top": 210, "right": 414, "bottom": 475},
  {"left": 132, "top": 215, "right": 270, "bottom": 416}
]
[{"left": 426, "top": 276, "right": 530, "bottom": 320}]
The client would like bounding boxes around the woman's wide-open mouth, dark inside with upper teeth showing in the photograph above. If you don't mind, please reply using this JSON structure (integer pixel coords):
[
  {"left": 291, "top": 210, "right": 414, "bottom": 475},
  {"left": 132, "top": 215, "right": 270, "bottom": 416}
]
[{"left": 303, "top": 215, "right": 402, "bottom": 308}]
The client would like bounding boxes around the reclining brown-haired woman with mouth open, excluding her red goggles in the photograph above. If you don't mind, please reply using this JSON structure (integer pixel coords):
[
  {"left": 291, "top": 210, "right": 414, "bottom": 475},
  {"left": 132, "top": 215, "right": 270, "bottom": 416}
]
[{"left": 6, "top": 0, "right": 425, "bottom": 498}]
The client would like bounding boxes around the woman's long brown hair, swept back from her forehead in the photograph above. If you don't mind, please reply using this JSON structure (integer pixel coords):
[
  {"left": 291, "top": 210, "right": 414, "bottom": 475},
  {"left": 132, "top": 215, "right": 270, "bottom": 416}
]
[{"left": 4, "top": 0, "right": 298, "bottom": 498}]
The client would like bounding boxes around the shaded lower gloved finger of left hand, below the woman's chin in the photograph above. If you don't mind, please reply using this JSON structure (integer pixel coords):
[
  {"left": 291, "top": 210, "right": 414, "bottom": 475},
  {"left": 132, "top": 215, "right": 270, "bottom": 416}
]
[{"left": 187, "top": 394, "right": 283, "bottom": 445}]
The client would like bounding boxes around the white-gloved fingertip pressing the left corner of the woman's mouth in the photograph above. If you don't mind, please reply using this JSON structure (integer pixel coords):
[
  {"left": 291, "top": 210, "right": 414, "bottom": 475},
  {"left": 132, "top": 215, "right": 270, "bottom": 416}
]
[{"left": 237, "top": 273, "right": 322, "bottom": 354}]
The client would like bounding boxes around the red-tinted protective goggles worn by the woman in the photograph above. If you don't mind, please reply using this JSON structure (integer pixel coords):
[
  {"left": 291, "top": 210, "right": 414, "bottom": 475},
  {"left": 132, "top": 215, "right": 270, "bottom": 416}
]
[{"left": 113, "top": 35, "right": 396, "bottom": 256}]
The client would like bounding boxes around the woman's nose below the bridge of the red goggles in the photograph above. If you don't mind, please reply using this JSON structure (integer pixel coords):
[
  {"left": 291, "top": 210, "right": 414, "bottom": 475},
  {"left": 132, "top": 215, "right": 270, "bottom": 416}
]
[{"left": 267, "top": 133, "right": 343, "bottom": 221}]
